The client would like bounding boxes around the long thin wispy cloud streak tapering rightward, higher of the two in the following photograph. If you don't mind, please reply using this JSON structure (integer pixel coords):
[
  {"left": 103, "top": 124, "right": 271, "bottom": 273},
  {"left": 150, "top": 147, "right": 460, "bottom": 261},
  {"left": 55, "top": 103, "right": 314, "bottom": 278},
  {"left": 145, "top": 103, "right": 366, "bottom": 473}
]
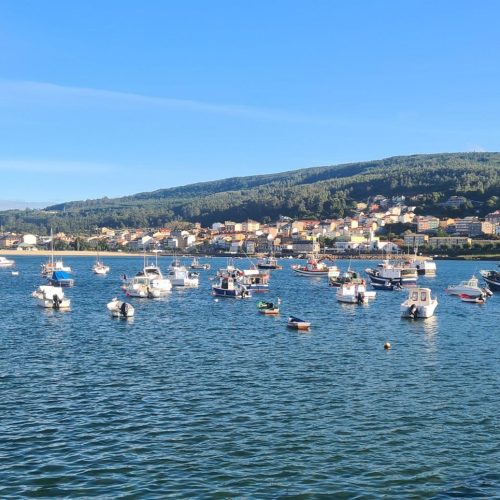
[{"left": 0, "top": 80, "right": 315, "bottom": 122}]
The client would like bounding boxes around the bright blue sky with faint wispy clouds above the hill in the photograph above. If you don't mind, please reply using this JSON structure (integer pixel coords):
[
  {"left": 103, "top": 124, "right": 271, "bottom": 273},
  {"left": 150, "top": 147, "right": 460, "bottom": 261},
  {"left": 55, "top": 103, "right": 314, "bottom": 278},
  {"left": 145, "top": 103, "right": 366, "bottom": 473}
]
[{"left": 0, "top": 0, "right": 500, "bottom": 202}]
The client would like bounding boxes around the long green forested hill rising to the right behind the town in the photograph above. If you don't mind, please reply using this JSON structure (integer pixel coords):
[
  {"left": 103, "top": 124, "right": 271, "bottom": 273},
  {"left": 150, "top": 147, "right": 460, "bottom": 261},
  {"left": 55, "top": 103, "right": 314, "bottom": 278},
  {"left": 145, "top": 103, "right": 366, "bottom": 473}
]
[{"left": 0, "top": 153, "right": 500, "bottom": 231}]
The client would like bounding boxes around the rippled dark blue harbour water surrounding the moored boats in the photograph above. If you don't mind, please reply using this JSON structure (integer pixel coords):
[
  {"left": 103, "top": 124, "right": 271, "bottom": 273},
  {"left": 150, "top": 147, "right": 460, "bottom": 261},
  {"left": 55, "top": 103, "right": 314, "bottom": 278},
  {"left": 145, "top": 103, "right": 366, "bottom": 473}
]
[{"left": 0, "top": 257, "right": 500, "bottom": 498}]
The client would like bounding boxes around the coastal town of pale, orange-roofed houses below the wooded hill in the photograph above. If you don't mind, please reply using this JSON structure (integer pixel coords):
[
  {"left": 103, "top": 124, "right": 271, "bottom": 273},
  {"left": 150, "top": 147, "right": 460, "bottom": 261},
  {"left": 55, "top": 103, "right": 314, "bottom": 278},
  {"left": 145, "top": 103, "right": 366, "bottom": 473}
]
[{"left": 0, "top": 195, "right": 500, "bottom": 257}]
